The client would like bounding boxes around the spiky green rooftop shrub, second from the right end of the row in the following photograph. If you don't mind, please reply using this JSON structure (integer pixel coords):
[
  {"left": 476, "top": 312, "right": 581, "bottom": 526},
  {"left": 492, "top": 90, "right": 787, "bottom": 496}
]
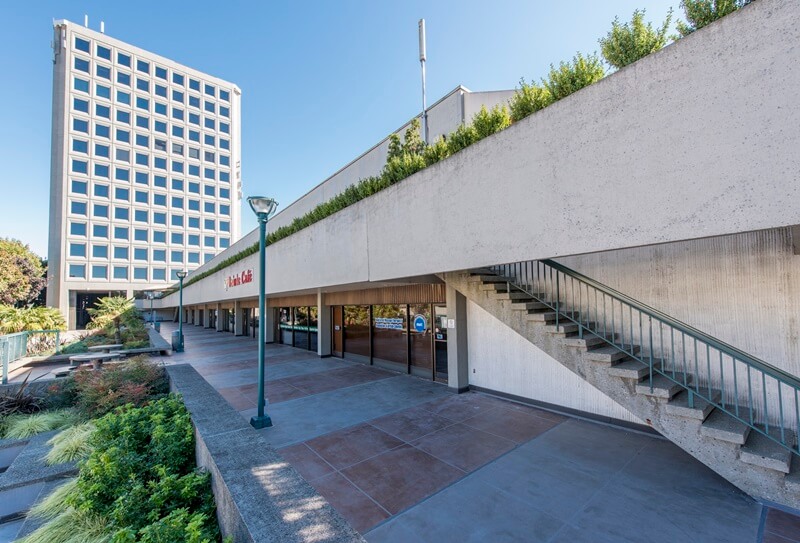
[{"left": 599, "top": 9, "right": 672, "bottom": 69}]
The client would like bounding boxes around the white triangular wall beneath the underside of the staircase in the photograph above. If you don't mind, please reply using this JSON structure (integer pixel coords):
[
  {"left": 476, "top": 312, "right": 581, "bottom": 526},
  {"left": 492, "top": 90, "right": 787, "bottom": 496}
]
[{"left": 467, "top": 301, "right": 643, "bottom": 424}]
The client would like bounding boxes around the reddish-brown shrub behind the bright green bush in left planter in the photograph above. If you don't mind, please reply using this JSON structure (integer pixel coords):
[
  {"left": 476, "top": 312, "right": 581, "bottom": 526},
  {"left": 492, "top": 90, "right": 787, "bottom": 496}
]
[{"left": 73, "top": 356, "right": 169, "bottom": 417}]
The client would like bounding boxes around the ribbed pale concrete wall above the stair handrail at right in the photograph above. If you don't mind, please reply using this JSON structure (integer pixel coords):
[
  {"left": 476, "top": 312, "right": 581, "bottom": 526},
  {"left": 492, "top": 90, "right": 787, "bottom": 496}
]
[{"left": 558, "top": 228, "right": 800, "bottom": 417}]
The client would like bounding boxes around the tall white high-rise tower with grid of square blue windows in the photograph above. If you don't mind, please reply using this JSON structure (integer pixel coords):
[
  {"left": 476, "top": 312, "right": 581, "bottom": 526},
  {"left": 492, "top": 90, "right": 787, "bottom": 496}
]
[{"left": 47, "top": 21, "right": 241, "bottom": 326}]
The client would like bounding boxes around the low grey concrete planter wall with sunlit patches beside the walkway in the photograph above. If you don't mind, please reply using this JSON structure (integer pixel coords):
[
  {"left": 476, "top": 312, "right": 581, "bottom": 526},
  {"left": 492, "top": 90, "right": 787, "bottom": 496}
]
[{"left": 167, "top": 364, "right": 365, "bottom": 543}]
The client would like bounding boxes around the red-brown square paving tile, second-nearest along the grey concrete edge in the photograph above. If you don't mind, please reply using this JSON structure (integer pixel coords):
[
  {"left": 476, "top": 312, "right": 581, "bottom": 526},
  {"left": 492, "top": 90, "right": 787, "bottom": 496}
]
[{"left": 342, "top": 445, "right": 464, "bottom": 515}]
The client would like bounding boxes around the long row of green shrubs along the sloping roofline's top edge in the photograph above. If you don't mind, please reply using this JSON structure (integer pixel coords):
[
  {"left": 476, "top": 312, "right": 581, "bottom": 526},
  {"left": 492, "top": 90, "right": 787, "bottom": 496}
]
[{"left": 177, "top": 0, "right": 751, "bottom": 295}]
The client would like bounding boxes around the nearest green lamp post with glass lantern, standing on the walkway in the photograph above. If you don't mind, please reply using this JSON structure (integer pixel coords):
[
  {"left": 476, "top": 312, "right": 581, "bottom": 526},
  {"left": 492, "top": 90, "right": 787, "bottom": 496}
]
[{"left": 247, "top": 196, "right": 278, "bottom": 429}]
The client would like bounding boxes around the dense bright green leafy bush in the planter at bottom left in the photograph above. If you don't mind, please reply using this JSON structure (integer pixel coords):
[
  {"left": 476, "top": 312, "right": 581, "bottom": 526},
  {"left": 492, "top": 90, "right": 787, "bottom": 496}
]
[{"left": 24, "top": 396, "right": 219, "bottom": 543}]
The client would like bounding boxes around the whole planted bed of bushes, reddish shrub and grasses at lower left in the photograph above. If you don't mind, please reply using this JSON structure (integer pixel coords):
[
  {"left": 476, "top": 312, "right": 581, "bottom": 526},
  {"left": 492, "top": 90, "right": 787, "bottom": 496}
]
[{"left": 0, "top": 357, "right": 227, "bottom": 543}]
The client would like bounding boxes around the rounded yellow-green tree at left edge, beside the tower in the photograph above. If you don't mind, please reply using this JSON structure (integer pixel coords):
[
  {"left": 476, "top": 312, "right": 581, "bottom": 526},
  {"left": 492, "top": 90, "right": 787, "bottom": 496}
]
[{"left": 0, "top": 238, "right": 47, "bottom": 306}]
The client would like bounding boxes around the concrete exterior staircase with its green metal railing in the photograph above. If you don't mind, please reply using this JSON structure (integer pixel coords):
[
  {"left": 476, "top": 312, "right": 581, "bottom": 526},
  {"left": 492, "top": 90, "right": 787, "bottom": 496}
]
[{"left": 442, "top": 260, "right": 800, "bottom": 509}]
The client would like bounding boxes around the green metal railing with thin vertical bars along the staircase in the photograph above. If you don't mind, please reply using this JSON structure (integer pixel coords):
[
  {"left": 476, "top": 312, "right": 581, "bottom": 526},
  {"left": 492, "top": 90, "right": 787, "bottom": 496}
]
[{"left": 490, "top": 259, "right": 800, "bottom": 456}]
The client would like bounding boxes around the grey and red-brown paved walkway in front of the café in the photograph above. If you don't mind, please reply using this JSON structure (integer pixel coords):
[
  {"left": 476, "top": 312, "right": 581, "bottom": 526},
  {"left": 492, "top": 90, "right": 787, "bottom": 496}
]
[{"left": 155, "top": 323, "right": 800, "bottom": 543}]
